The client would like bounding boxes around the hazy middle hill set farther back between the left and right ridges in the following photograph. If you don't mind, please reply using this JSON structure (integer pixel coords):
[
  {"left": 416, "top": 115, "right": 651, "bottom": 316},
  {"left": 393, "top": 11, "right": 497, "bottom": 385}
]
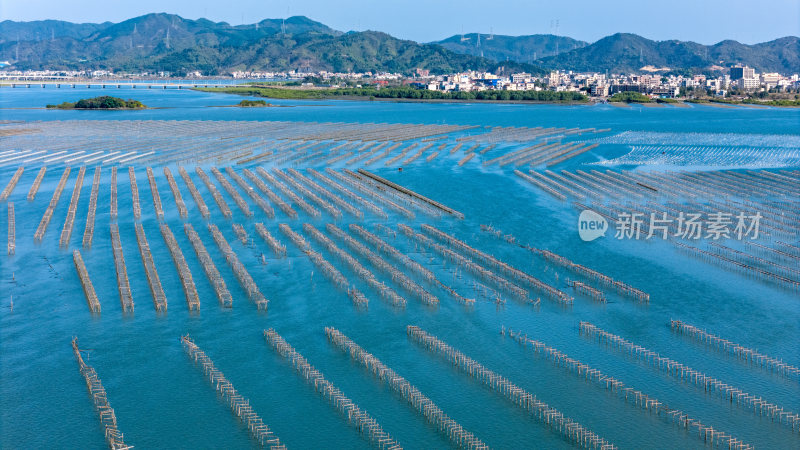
[{"left": 431, "top": 33, "right": 589, "bottom": 63}]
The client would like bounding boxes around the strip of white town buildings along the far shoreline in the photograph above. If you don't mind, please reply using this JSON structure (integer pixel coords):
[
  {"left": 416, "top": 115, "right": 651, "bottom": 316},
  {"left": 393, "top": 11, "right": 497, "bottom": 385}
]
[{"left": 0, "top": 64, "right": 800, "bottom": 101}]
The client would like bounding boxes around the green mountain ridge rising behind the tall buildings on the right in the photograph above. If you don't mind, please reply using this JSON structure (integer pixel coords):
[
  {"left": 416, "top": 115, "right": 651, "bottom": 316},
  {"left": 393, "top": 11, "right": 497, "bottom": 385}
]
[{"left": 536, "top": 33, "right": 800, "bottom": 74}]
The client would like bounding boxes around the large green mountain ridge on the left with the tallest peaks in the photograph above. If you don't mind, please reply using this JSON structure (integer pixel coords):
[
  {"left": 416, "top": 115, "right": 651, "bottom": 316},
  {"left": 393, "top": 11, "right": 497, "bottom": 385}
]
[{"left": 0, "top": 13, "right": 542, "bottom": 74}]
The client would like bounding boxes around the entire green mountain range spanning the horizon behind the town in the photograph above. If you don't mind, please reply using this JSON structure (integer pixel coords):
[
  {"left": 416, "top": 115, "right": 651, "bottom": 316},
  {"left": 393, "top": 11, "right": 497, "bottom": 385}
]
[{"left": 0, "top": 13, "right": 800, "bottom": 75}]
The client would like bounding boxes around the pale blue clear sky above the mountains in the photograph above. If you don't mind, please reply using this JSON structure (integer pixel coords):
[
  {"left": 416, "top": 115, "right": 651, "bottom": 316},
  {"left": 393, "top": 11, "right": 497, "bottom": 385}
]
[{"left": 0, "top": 0, "right": 800, "bottom": 44}]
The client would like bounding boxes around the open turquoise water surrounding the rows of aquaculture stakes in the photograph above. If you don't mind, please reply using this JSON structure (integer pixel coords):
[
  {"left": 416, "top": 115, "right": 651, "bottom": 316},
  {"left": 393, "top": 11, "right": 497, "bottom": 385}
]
[{"left": 0, "top": 89, "right": 800, "bottom": 448}]
